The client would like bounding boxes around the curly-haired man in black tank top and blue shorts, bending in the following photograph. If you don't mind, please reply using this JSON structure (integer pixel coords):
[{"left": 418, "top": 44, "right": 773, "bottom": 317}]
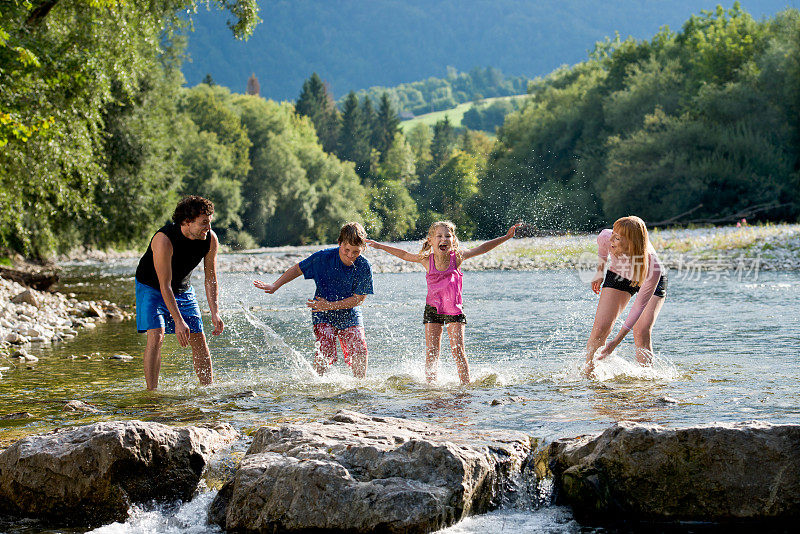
[{"left": 136, "top": 196, "right": 223, "bottom": 390}]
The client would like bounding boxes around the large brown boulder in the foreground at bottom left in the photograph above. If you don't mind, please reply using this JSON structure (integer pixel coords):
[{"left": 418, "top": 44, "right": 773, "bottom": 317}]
[{"left": 0, "top": 421, "right": 236, "bottom": 526}]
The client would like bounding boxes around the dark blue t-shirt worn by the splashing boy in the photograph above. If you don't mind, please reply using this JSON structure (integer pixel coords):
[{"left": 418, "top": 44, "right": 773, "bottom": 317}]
[{"left": 300, "top": 247, "right": 373, "bottom": 329}]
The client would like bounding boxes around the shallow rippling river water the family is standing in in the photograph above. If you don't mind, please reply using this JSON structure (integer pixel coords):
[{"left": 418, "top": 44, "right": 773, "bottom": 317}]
[{"left": 0, "top": 258, "right": 800, "bottom": 533}]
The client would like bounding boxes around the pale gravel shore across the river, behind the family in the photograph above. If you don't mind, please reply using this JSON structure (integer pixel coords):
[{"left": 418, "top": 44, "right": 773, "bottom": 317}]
[{"left": 219, "top": 224, "right": 800, "bottom": 274}]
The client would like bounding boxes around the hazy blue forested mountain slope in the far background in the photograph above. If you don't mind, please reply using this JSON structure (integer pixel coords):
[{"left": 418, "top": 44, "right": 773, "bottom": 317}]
[{"left": 182, "top": 0, "right": 798, "bottom": 100}]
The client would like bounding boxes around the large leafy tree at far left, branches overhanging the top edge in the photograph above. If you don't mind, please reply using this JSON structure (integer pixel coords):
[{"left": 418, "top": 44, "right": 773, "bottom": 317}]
[{"left": 0, "top": 0, "right": 257, "bottom": 256}]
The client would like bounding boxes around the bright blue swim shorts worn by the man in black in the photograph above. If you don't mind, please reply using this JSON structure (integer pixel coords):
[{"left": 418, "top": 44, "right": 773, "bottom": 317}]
[{"left": 136, "top": 280, "right": 203, "bottom": 334}]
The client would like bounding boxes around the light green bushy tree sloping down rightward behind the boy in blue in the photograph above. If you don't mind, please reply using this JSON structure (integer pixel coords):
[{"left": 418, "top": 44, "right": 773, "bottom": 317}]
[{"left": 232, "top": 95, "right": 372, "bottom": 245}]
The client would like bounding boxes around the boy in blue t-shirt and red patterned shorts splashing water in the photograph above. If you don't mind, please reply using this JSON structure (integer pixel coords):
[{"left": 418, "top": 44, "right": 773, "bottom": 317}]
[{"left": 253, "top": 222, "right": 373, "bottom": 378}]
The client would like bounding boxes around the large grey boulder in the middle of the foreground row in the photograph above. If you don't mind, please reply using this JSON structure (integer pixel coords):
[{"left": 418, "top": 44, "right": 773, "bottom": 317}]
[{"left": 209, "top": 411, "right": 531, "bottom": 533}]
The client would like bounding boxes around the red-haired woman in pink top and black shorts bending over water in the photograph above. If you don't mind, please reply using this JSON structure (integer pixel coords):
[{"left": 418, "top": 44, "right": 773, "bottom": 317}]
[{"left": 585, "top": 216, "right": 667, "bottom": 376}]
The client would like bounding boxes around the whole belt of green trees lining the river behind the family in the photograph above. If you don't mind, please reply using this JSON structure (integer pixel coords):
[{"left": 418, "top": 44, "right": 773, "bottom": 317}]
[{"left": 0, "top": 0, "right": 800, "bottom": 257}]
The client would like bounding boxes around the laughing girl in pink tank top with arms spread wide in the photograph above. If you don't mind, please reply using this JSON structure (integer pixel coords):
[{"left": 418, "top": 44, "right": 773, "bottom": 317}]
[{"left": 367, "top": 221, "right": 519, "bottom": 384}]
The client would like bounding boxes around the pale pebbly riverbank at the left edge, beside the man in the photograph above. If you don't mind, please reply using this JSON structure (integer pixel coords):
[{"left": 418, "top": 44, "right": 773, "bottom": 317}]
[{"left": 0, "top": 278, "right": 131, "bottom": 361}]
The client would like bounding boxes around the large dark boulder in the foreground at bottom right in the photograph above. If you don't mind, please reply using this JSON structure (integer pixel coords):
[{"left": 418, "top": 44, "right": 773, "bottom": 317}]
[{"left": 549, "top": 422, "right": 800, "bottom": 522}]
